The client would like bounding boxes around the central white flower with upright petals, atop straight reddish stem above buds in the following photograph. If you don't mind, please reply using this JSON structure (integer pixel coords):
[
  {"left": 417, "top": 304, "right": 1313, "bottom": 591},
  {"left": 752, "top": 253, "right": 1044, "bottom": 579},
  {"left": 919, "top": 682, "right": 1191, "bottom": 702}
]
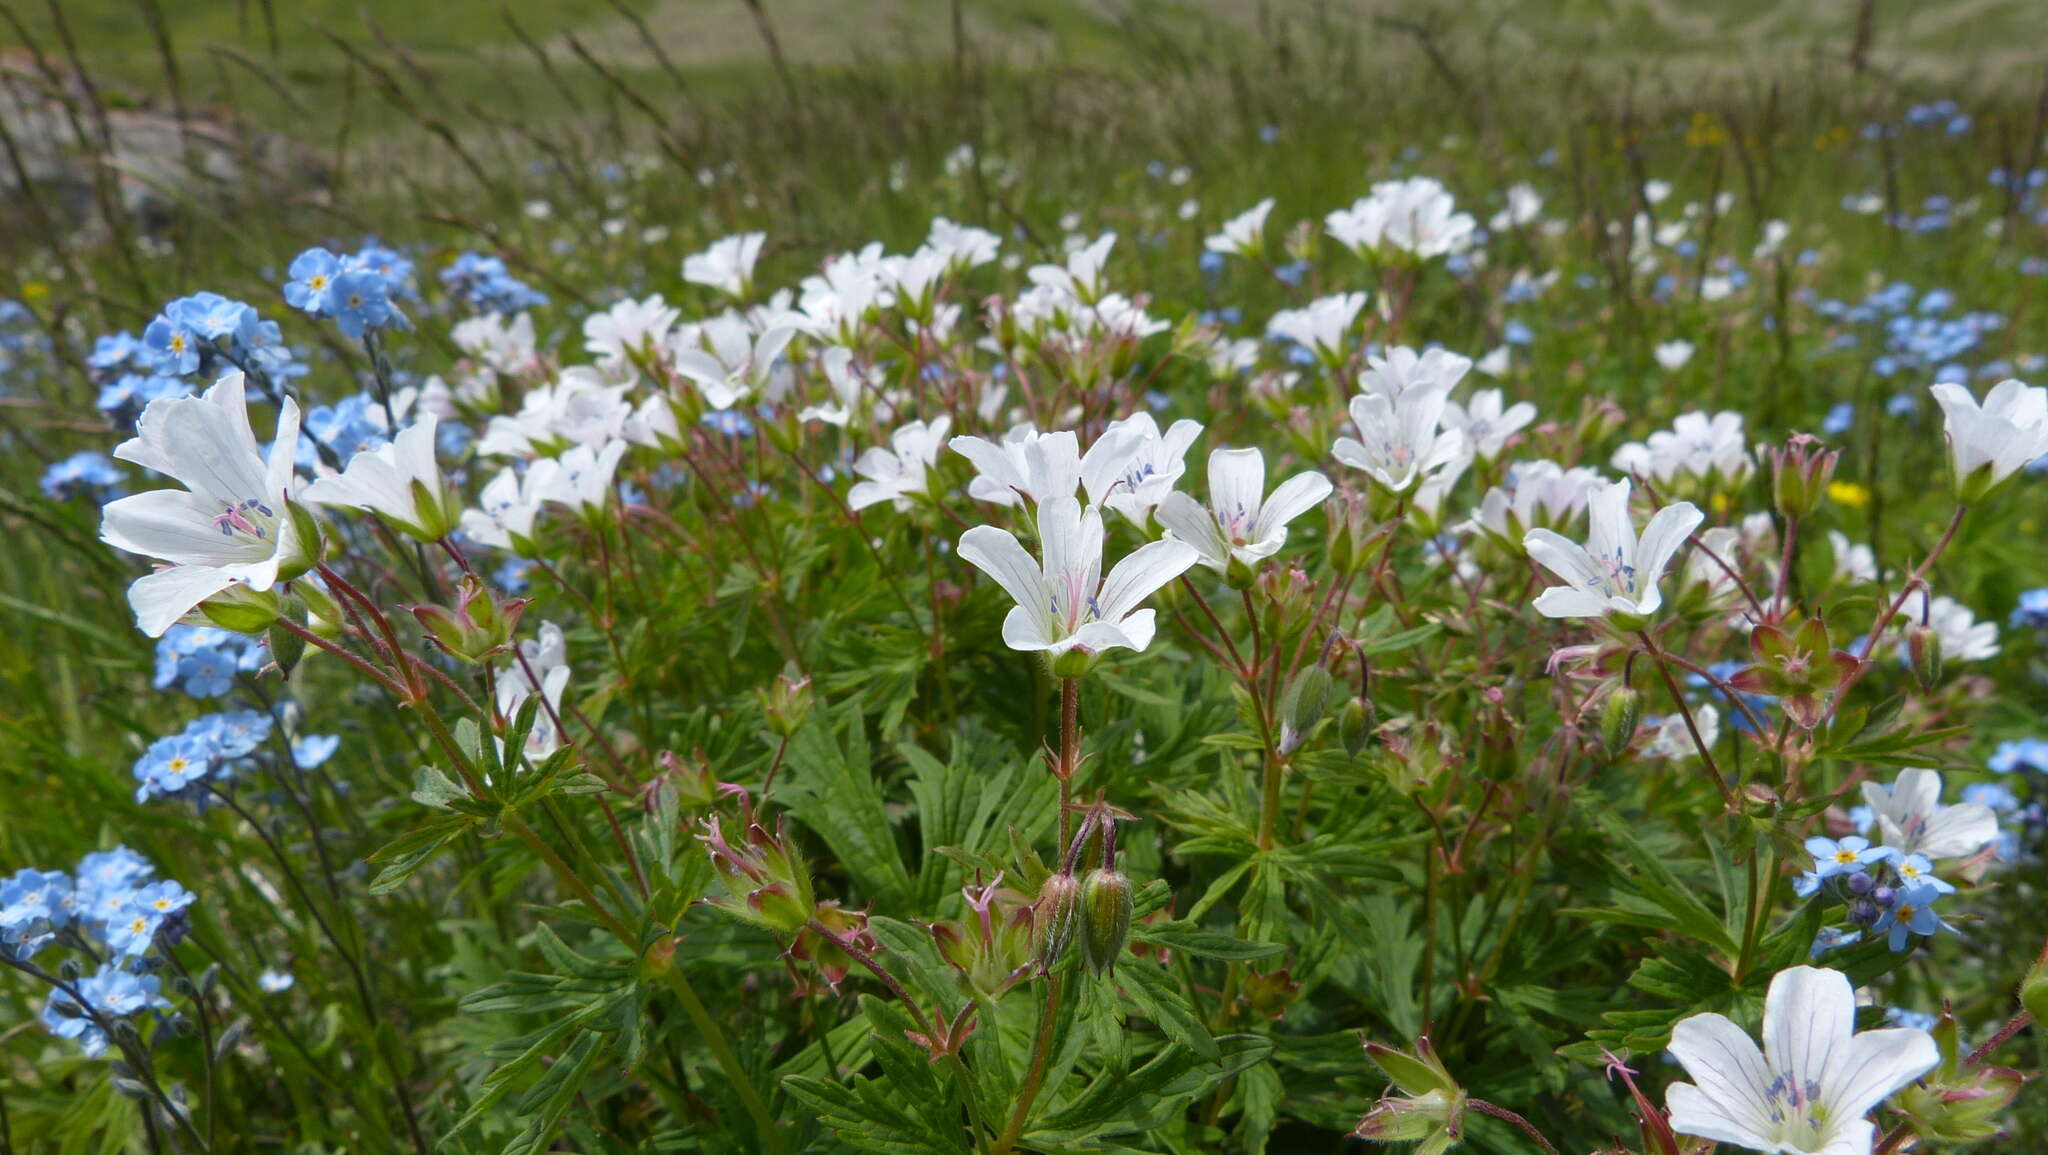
[{"left": 961, "top": 496, "right": 1200, "bottom": 657}]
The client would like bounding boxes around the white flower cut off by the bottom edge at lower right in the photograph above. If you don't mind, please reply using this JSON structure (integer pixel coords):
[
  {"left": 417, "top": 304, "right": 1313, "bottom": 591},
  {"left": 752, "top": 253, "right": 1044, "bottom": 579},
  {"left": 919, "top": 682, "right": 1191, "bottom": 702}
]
[{"left": 1665, "top": 967, "right": 1942, "bottom": 1155}]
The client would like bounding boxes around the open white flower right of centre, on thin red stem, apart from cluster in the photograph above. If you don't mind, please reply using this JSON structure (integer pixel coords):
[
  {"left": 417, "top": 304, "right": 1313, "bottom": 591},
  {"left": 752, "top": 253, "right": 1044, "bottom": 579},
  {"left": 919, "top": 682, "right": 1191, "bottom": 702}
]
[{"left": 1522, "top": 481, "right": 1706, "bottom": 618}]
